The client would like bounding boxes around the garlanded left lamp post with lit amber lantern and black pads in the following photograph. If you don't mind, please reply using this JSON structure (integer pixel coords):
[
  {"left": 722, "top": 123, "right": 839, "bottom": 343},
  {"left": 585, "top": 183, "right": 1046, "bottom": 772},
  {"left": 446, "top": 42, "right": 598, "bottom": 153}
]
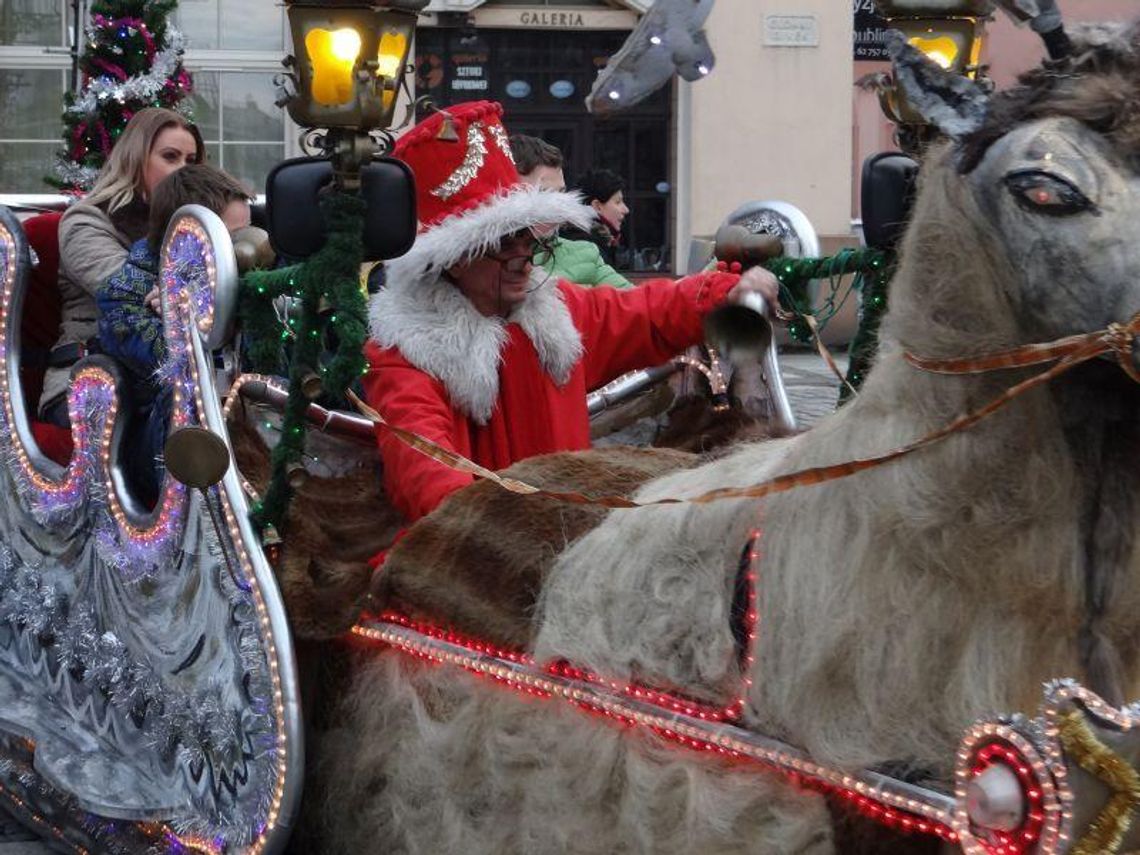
[{"left": 243, "top": 0, "right": 429, "bottom": 535}]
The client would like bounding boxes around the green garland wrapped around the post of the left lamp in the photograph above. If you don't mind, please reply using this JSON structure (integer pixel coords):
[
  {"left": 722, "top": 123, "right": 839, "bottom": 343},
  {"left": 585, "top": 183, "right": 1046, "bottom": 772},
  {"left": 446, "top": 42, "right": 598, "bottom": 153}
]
[{"left": 239, "top": 192, "right": 367, "bottom": 531}]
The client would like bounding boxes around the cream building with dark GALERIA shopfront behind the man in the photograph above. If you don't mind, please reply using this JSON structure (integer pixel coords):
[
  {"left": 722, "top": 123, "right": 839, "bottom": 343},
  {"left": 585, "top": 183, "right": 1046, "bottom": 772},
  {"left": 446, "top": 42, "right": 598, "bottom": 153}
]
[{"left": 416, "top": 0, "right": 853, "bottom": 272}]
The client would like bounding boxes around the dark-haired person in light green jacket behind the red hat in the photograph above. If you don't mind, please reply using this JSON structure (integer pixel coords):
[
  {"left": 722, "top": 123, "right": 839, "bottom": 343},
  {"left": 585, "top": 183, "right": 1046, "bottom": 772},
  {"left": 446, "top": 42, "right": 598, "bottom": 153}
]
[{"left": 511, "top": 133, "right": 633, "bottom": 288}]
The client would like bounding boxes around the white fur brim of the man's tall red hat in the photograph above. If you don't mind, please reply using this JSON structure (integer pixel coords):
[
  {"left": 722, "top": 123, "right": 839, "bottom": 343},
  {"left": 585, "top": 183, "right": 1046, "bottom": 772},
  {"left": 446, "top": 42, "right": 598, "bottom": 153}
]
[{"left": 388, "top": 185, "right": 595, "bottom": 280}]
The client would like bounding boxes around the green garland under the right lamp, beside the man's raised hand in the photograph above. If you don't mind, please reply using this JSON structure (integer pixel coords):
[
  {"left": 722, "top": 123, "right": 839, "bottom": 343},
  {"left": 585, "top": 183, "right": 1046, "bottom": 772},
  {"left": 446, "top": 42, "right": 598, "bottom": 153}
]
[{"left": 765, "top": 250, "right": 895, "bottom": 401}]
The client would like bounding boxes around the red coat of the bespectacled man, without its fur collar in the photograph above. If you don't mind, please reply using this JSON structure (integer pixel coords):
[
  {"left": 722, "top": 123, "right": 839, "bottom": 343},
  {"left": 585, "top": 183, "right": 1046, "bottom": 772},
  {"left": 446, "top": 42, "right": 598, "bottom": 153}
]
[{"left": 364, "top": 272, "right": 739, "bottom": 522}]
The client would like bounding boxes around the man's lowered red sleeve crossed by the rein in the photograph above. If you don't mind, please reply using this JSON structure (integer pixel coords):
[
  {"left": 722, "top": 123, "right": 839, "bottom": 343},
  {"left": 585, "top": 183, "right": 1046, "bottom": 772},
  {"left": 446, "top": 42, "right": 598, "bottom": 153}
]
[{"left": 364, "top": 342, "right": 474, "bottom": 522}]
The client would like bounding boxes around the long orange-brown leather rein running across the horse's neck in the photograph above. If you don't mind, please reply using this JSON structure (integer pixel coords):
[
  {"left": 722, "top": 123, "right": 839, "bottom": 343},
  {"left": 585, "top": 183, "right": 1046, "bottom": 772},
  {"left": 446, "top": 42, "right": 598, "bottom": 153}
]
[{"left": 348, "top": 312, "right": 1140, "bottom": 508}]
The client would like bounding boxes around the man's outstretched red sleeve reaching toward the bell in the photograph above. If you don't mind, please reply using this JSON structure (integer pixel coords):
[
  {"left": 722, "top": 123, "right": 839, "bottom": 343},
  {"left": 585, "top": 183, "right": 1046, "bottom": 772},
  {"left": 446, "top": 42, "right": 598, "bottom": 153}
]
[{"left": 560, "top": 272, "right": 740, "bottom": 389}]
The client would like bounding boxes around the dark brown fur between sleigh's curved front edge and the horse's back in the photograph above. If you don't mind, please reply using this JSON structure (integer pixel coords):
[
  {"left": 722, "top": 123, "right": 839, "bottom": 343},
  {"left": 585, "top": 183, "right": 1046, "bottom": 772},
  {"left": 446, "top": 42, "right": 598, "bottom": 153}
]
[{"left": 229, "top": 410, "right": 404, "bottom": 640}]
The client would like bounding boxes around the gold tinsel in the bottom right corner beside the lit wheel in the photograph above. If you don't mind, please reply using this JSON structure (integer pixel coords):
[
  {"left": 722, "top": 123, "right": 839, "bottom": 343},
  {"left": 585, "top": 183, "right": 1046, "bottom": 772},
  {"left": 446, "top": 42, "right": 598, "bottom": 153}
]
[{"left": 1059, "top": 710, "right": 1140, "bottom": 855}]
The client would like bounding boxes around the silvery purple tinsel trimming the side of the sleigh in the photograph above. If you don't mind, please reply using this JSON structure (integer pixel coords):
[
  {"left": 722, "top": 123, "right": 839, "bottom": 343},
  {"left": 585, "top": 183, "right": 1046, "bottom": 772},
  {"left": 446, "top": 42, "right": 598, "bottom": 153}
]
[{"left": 0, "top": 215, "right": 278, "bottom": 848}]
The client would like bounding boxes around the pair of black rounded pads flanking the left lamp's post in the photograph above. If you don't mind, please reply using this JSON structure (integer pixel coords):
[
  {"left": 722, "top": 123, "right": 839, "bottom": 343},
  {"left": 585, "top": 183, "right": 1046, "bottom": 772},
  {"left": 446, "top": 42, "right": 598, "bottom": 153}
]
[{"left": 266, "top": 157, "right": 416, "bottom": 261}]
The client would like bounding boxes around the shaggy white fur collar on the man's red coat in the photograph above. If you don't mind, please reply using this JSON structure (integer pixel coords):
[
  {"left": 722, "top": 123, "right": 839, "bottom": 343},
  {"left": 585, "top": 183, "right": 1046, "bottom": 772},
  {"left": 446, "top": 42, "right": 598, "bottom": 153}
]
[{"left": 369, "top": 269, "right": 583, "bottom": 424}]
